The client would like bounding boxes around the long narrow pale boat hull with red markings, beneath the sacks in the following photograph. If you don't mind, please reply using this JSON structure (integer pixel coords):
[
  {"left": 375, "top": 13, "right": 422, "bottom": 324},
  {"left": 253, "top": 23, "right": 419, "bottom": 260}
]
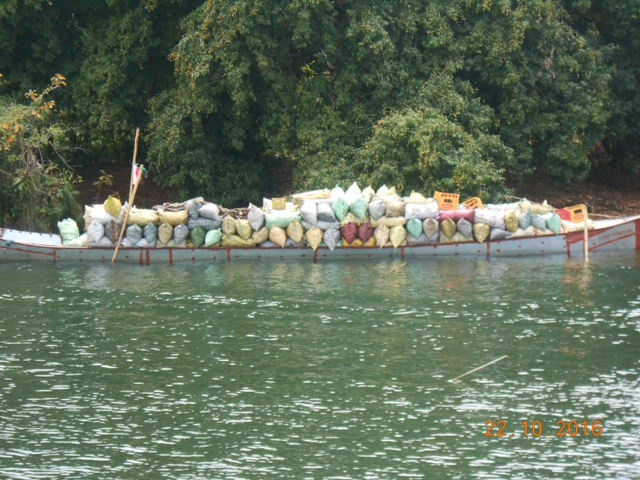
[{"left": 0, "top": 215, "right": 640, "bottom": 265}]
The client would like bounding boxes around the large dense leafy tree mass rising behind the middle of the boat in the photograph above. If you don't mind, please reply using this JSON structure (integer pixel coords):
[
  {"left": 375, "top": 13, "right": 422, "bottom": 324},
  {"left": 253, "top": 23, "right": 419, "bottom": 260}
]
[{"left": 150, "top": 0, "right": 609, "bottom": 200}]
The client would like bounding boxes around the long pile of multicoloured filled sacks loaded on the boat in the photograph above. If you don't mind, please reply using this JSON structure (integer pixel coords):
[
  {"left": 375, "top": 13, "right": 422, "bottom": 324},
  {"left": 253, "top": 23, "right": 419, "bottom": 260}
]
[{"left": 65, "top": 183, "right": 594, "bottom": 250}]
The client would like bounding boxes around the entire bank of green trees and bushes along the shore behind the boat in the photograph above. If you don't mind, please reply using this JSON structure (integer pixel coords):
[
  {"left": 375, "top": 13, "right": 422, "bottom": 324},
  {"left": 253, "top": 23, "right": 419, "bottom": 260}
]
[{"left": 0, "top": 0, "right": 640, "bottom": 231}]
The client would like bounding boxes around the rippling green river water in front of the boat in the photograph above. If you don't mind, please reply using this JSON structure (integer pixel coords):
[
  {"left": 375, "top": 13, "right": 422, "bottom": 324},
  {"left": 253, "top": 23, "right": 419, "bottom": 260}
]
[{"left": 0, "top": 254, "right": 640, "bottom": 479}]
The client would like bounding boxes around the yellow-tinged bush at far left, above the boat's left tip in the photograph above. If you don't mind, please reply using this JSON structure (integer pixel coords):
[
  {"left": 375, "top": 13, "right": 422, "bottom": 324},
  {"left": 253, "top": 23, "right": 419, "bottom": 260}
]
[{"left": 0, "top": 75, "right": 81, "bottom": 231}]
